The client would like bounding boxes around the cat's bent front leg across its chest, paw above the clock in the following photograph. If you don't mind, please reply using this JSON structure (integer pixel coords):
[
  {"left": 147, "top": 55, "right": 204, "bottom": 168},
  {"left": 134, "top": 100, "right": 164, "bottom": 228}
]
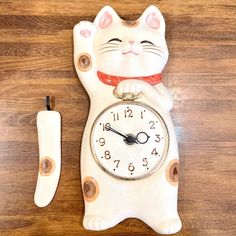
[{"left": 115, "top": 79, "right": 173, "bottom": 111}]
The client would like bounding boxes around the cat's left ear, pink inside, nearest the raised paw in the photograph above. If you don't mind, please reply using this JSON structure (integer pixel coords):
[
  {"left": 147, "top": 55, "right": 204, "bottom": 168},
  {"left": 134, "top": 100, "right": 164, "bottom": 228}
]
[{"left": 94, "top": 6, "right": 120, "bottom": 29}]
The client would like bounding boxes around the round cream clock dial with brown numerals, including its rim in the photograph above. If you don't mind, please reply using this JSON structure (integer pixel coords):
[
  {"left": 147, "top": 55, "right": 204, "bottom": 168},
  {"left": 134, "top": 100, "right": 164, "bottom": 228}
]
[{"left": 90, "top": 102, "right": 169, "bottom": 180}]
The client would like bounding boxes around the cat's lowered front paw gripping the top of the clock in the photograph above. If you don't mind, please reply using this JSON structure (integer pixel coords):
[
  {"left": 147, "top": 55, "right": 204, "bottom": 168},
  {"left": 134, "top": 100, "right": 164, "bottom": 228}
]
[{"left": 115, "top": 79, "right": 149, "bottom": 95}]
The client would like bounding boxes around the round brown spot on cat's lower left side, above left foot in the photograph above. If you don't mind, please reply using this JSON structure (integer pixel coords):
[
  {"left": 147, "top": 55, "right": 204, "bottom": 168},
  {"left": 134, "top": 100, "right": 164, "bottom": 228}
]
[{"left": 83, "top": 177, "right": 99, "bottom": 202}]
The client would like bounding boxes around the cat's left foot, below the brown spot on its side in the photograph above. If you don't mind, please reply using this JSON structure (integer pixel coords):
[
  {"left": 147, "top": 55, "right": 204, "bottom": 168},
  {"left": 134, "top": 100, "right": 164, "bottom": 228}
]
[{"left": 83, "top": 215, "right": 113, "bottom": 231}]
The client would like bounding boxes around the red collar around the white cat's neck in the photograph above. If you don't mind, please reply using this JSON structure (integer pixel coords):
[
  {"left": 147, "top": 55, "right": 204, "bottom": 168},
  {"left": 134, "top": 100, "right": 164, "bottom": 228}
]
[{"left": 97, "top": 71, "right": 162, "bottom": 86}]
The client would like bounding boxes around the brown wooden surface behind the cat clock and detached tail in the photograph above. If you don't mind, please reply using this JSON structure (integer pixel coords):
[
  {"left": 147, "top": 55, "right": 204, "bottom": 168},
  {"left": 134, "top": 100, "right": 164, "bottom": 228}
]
[{"left": 0, "top": 0, "right": 236, "bottom": 236}]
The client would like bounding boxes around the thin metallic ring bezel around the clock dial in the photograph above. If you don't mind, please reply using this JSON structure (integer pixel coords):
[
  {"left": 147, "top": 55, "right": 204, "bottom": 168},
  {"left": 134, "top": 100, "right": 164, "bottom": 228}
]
[{"left": 90, "top": 101, "right": 170, "bottom": 181}]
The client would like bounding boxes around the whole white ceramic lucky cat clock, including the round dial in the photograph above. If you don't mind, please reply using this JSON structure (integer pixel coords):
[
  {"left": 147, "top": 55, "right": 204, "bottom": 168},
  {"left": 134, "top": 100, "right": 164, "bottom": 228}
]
[{"left": 74, "top": 6, "right": 181, "bottom": 234}]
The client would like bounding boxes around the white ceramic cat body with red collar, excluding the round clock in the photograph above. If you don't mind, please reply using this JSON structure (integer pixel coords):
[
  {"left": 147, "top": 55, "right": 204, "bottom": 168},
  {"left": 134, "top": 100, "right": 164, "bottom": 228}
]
[{"left": 74, "top": 6, "right": 181, "bottom": 234}]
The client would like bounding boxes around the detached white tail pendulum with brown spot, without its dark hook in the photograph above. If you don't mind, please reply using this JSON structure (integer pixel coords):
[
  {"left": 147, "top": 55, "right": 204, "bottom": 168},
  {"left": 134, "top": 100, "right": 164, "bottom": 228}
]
[{"left": 34, "top": 111, "right": 61, "bottom": 207}]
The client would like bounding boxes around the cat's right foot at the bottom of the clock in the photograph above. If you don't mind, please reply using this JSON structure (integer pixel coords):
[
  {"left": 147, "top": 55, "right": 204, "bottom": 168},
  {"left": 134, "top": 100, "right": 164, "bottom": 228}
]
[{"left": 156, "top": 218, "right": 182, "bottom": 234}]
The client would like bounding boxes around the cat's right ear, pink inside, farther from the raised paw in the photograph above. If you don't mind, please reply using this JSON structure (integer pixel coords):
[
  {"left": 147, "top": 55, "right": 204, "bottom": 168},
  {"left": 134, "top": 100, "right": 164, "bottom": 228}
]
[{"left": 139, "top": 5, "right": 165, "bottom": 35}]
